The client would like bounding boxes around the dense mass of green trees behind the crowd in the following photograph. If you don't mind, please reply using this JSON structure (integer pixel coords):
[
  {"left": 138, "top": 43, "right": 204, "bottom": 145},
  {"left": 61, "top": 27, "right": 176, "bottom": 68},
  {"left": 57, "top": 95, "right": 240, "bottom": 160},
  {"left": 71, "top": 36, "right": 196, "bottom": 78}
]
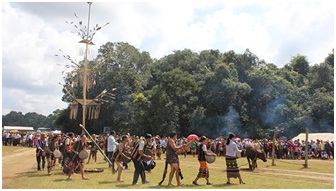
[{"left": 3, "top": 42, "right": 334, "bottom": 138}]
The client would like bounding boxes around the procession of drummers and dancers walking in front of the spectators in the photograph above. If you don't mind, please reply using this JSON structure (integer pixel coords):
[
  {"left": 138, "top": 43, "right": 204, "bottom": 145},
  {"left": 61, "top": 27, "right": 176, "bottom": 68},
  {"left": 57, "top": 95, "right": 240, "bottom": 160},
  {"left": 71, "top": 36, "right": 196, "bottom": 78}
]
[{"left": 32, "top": 131, "right": 249, "bottom": 186}]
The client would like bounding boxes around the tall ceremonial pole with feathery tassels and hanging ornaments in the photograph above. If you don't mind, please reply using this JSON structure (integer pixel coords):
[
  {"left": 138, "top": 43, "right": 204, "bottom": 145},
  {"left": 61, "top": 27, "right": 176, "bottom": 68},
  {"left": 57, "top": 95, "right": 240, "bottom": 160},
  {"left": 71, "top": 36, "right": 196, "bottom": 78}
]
[{"left": 56, "top": 2, "right": 110, "bottom": 134}]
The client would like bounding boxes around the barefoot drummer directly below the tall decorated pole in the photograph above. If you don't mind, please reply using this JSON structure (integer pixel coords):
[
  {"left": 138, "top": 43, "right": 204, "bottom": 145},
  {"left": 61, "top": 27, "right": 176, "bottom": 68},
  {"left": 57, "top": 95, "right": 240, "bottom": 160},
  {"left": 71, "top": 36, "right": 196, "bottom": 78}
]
[{"left": 67, "top": 134, "right": 89, "bottom": 180}]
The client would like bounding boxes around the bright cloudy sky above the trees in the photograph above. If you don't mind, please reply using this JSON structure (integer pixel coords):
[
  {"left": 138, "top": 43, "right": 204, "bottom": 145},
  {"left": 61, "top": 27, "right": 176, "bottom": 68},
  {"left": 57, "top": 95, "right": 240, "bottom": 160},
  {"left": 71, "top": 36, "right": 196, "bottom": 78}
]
[{"left": 1, "top": 0, "right": 335, "bottom": 116}]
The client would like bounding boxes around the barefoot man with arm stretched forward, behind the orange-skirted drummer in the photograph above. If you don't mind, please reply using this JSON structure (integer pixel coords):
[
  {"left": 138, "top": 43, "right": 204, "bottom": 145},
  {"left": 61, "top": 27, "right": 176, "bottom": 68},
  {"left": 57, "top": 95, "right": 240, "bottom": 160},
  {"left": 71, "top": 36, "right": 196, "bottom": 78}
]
[{"left": 166, "top": 132, "right": 193, "bottom": 186}]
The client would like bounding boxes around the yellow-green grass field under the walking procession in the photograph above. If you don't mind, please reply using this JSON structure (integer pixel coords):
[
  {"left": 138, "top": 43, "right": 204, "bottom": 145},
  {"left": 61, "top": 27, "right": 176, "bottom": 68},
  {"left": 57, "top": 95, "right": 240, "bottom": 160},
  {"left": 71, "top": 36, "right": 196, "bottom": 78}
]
[{"left": 2, "top": 147, "right": 334, "bottom": 189}]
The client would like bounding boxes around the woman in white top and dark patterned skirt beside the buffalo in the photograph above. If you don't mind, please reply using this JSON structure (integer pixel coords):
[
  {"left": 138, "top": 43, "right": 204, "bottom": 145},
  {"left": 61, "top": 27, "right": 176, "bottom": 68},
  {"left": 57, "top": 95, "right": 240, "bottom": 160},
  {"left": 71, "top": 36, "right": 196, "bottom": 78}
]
[{"left": 225, "top": 133, "right": 245, "bottom": 184}]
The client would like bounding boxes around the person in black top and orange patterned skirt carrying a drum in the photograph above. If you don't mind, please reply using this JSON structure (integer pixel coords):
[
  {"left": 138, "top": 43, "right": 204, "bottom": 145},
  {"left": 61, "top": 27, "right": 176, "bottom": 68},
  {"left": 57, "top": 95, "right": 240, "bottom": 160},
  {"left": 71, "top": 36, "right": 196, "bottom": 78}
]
[{"left": 192, "top": 136, "right": 216, "bottom": 185}]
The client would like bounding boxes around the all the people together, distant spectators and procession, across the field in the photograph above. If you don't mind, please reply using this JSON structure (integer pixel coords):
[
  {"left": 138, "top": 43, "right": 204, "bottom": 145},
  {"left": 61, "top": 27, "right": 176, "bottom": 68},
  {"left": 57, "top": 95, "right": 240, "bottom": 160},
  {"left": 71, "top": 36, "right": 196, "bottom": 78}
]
[{"left": 2, "top": 131, "right": 334, "bottom": 186}]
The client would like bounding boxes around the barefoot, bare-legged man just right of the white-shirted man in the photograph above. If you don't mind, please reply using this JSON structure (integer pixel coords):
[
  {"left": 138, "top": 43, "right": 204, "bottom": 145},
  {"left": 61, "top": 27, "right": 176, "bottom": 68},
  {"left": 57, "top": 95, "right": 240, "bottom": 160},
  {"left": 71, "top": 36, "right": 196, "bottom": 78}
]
[{"left": 115, "top": 135, "right": 131, "bottom": 182}]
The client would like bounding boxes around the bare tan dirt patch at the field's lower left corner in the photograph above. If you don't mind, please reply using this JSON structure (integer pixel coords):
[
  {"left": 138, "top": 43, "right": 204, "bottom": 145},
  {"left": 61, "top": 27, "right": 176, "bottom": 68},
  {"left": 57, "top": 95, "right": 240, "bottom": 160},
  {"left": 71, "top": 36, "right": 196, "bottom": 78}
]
[{"left": 2, "top": 147, "right": 37, "bottom": 188}]
